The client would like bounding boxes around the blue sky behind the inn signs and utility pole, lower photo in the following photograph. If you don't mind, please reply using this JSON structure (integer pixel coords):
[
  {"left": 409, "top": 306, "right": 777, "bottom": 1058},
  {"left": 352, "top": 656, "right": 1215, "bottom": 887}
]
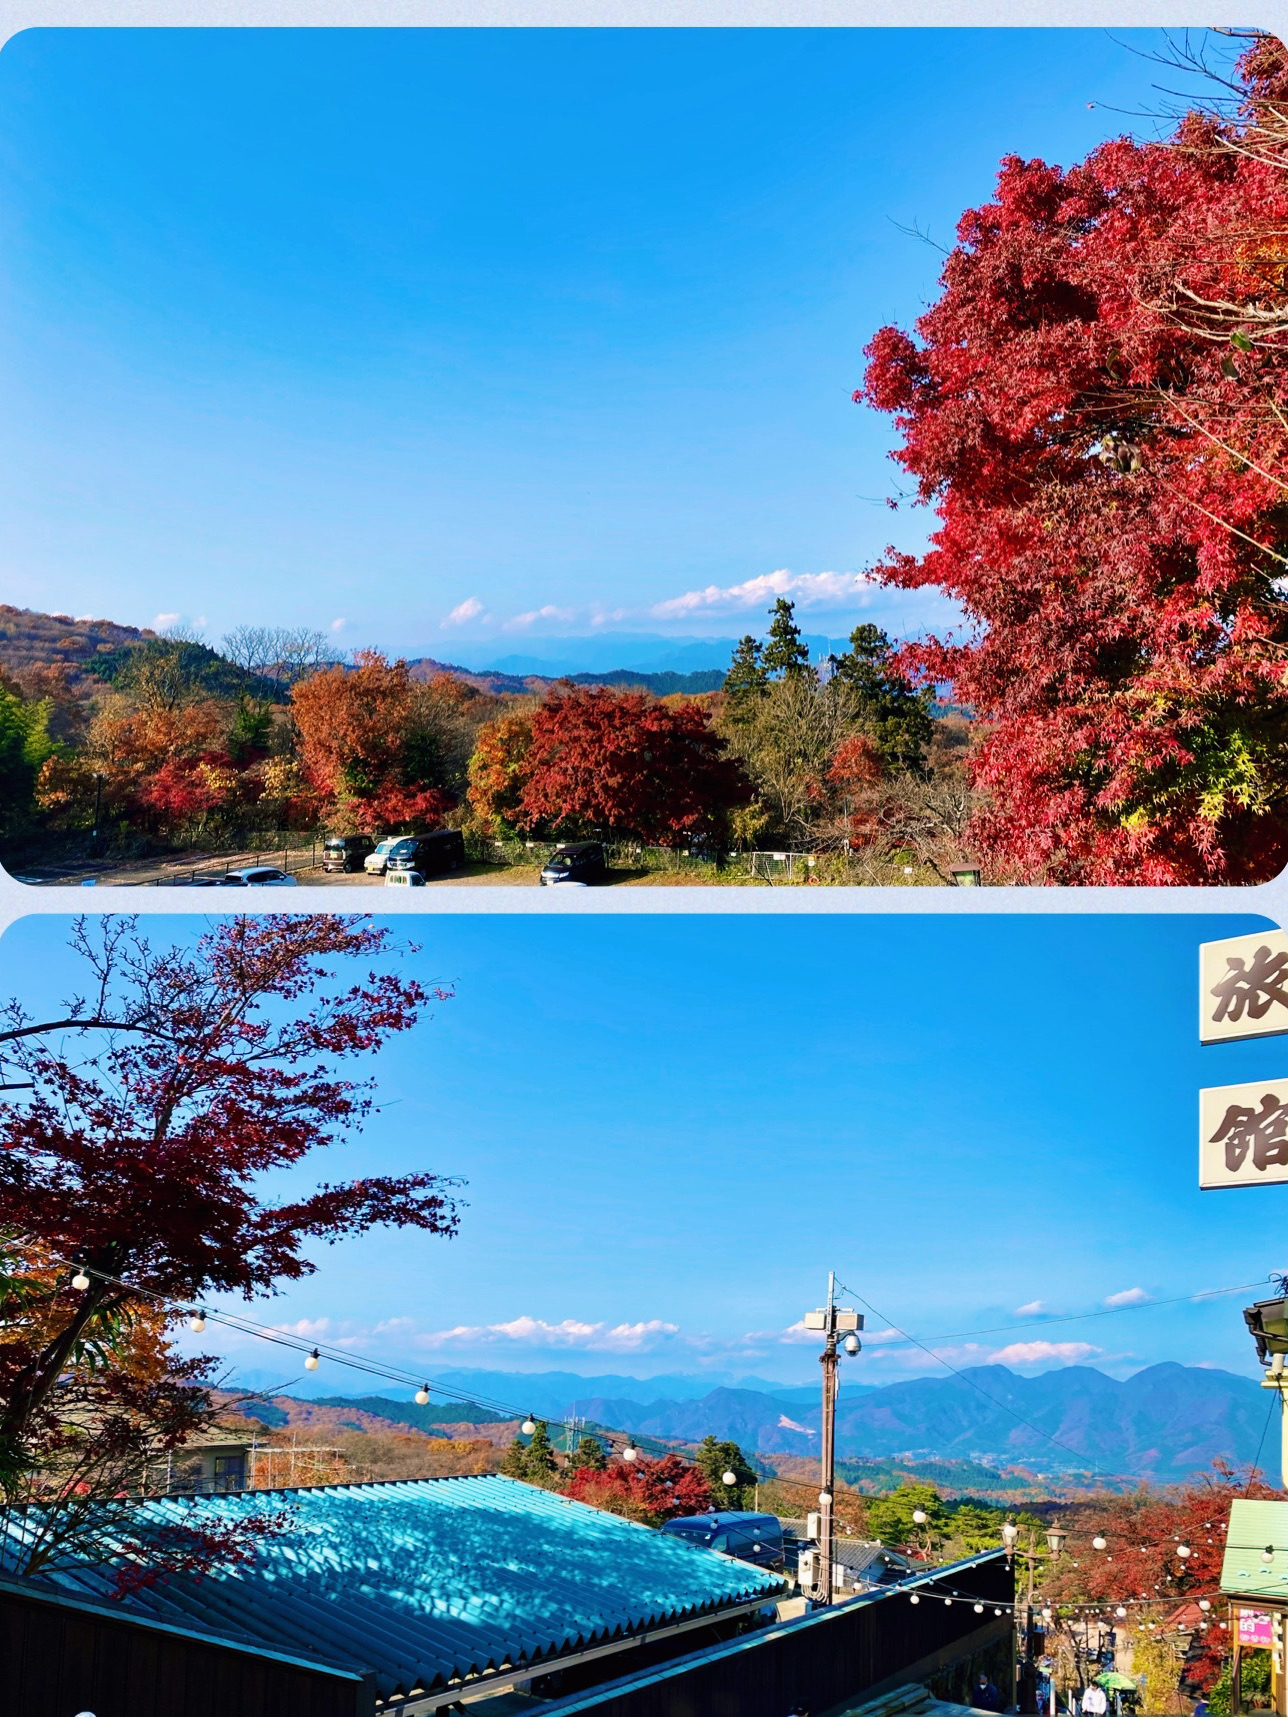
[{"left": 0, "top": 913, "right": 1288, "bottom": 1391}]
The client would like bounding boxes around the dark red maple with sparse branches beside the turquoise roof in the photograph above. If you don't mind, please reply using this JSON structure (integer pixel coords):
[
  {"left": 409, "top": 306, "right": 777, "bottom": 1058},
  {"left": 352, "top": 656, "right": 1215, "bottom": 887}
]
[{"left": 0, "top": 915, "right": 459, "bottom": 1572}]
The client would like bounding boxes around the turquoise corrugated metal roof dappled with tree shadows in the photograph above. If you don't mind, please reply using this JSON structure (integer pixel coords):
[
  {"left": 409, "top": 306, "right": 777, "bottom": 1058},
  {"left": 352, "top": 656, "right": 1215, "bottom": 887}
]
[{"left": 32, "top": 1477, "right": 785, "bottom": 1698}]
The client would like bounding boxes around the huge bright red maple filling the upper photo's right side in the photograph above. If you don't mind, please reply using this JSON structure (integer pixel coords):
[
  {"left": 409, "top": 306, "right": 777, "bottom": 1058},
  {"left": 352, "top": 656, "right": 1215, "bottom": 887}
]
[{"left": 855, "top": 38, "right": 1288, "bottom": 883}]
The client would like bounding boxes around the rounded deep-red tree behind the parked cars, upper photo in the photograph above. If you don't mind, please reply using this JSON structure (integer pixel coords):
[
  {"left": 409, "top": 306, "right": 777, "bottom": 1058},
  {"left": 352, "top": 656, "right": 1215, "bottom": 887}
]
[{"left": 515, "top": 687, "right": 750, "bottom": 846}]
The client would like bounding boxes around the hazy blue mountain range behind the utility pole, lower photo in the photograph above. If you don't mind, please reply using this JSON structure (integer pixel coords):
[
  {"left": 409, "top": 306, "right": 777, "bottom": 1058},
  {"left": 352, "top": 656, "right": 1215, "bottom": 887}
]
[{"left": 242, "top": 1363, "right": 1266, "bottom": 1483}]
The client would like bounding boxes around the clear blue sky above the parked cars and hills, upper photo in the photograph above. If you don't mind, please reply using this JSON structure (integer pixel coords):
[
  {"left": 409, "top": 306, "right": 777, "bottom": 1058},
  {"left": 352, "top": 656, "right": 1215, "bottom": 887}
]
[{"left": 0, "top": 29, "right": 1229, "bottom": 661}]
